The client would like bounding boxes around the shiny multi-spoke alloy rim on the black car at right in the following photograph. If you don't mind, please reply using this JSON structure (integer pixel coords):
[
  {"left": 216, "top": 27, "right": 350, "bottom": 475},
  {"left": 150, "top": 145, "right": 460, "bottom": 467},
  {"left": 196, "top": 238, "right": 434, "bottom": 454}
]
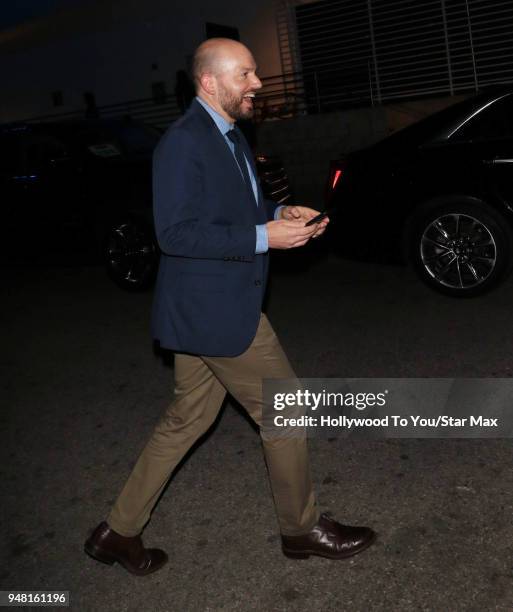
[{"left": 420, "top": 213, "right": 497, "bottom": 290}]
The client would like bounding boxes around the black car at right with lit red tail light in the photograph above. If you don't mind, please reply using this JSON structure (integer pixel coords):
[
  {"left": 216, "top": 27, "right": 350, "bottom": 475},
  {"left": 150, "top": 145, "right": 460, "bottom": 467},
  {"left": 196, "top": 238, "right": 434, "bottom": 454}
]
[{"left": 328, "top": 87, "right": 513, "bottom": 297}]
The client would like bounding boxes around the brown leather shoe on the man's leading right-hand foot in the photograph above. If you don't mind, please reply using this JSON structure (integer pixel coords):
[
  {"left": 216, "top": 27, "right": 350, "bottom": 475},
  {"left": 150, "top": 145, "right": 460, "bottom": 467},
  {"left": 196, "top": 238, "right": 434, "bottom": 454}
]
[{"left": 281, "top": 514, "right": 376, "bottom": 559}]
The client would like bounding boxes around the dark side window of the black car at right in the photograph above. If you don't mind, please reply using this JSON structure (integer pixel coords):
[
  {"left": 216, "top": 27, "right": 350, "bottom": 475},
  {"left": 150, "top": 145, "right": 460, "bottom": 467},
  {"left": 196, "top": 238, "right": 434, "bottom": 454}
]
[{"left": 451, "top": 95, "right": 513, "bottom": 141}]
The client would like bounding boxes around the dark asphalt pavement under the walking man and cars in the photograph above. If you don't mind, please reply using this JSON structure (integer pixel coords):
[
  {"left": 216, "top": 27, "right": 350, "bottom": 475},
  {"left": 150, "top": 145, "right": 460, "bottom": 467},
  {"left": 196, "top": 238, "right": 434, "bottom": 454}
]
[{"left": 0, "top": 251, "right": 513, "bottom": 612}]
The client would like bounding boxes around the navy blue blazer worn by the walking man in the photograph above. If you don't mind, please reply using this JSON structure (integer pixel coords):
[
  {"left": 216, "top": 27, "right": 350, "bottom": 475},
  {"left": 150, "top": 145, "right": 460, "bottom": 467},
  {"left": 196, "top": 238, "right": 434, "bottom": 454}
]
[{"left": 152, "top": 101, "right": 277, "bottom": 357}]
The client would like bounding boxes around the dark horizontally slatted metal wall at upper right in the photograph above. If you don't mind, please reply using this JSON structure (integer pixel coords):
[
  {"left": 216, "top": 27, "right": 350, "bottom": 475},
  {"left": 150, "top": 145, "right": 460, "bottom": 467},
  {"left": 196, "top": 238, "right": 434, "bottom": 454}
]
[{"left": 278, "top": 0, "right": 513, "bottom": 110}]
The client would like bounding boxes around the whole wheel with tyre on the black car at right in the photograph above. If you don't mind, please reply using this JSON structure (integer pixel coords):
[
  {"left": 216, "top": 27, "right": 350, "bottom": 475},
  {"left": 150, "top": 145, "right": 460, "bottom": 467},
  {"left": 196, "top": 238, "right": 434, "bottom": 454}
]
[{"left": 410, "top": 199, "right": 513, "bottom": 297}]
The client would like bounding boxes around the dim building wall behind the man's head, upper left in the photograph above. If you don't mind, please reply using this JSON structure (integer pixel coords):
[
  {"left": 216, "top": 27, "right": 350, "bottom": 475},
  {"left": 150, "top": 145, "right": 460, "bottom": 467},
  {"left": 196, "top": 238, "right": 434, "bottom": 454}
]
[{"left": 0, "top": 0, "right": 281, "bottom": 122}]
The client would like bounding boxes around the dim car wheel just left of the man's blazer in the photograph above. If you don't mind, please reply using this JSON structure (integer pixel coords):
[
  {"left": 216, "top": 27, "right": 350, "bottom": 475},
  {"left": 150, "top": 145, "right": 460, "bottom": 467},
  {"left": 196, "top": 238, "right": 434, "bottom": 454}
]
[{"left": 105, "top": 221, "right": 159, "bottom": 291}]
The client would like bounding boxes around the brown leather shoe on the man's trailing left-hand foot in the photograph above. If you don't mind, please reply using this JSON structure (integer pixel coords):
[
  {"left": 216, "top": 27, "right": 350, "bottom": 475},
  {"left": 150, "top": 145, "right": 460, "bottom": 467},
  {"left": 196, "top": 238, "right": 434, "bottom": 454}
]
[{"left": 84, "top": 521, "right": 168, "bottom": 576}]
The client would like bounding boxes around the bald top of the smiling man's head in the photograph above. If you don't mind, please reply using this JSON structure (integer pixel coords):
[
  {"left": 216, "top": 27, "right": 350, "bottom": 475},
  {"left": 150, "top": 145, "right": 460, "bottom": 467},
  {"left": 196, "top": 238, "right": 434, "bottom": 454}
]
[{"left": 192, "top": 38, "right": 251, "bottom": 90}]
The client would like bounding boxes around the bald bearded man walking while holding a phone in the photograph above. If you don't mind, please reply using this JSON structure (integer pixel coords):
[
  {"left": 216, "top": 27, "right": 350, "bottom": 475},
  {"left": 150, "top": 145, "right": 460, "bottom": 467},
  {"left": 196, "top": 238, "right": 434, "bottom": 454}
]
[{"left": 85, "top": 39, "right": 375, "bottom": 575}]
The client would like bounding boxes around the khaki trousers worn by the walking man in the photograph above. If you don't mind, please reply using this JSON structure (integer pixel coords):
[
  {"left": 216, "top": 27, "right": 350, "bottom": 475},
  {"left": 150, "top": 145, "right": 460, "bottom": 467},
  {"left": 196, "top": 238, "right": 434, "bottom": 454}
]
[{"left": 107, "top": 315, "right": 319, "bottom": 536}]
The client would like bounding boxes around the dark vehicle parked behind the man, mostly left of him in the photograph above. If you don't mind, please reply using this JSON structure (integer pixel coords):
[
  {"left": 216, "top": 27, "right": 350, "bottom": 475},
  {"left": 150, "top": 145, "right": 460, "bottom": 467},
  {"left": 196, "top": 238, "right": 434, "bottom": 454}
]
[{"left": 0, "top": 119, "right": 290, "bottom": 289}]
